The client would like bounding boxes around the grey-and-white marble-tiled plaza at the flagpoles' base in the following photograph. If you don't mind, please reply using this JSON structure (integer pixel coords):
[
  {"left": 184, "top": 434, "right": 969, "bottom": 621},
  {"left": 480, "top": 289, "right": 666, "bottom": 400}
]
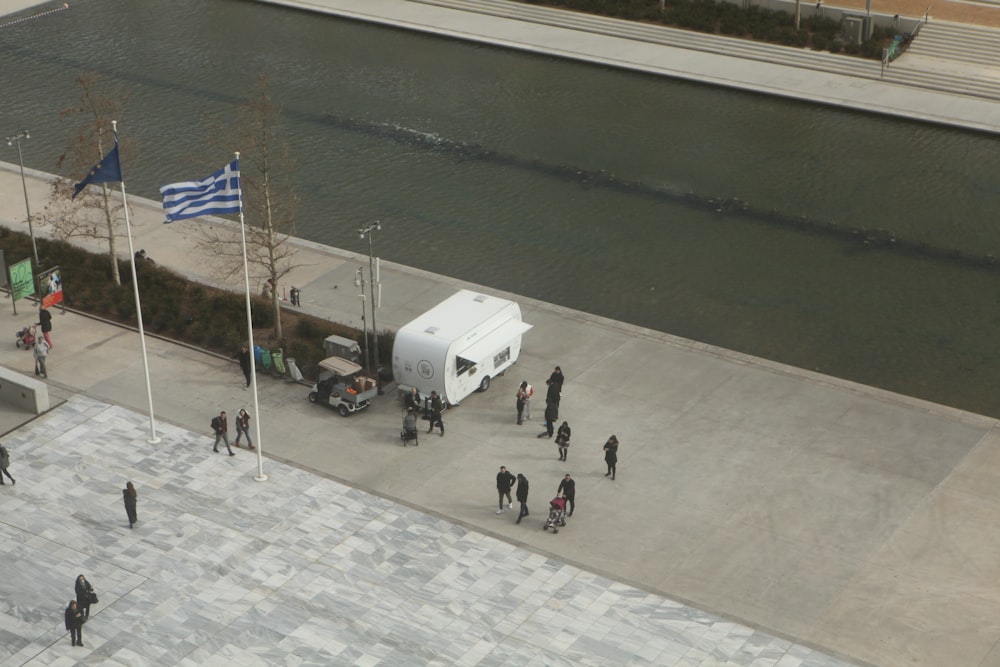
[{"left": 0, "top": 395, "right": 860, "bottom": 667}]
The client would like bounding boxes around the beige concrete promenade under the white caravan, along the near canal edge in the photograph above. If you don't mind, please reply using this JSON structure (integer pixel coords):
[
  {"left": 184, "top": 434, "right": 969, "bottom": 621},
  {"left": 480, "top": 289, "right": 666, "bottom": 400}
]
[{"left": 0, "top": 160, "right": 1000, "bottom": 667}]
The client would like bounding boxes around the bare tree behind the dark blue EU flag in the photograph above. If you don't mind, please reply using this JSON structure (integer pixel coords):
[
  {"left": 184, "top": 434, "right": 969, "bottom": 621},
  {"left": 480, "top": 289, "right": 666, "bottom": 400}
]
[{"left": 40, "top": 73, "right": 129, "bottom": 285}]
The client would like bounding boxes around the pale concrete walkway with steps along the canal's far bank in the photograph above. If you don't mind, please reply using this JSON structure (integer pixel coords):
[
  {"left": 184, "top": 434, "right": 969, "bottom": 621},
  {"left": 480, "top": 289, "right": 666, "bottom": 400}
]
[{"left": 257, "top": 0, "right": 1000, "bottom": 132}]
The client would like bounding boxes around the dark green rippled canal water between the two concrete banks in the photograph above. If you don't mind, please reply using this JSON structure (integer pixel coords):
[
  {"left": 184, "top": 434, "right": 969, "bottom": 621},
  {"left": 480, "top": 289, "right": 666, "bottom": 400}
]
[{"left": 0, "top": 0, "right": 1000, "bottom": 415}]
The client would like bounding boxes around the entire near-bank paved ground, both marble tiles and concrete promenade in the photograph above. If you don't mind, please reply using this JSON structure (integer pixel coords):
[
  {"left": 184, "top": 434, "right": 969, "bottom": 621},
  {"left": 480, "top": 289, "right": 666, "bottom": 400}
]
[{"left": 0, "top": 0, "right": 1000, "bottom": 667}]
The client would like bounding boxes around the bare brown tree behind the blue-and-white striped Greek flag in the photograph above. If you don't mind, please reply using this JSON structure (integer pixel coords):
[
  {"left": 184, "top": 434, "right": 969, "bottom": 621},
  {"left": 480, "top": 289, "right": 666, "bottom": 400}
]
[{"left": 200, "top": 73, "right": 298, "bottom": 340}]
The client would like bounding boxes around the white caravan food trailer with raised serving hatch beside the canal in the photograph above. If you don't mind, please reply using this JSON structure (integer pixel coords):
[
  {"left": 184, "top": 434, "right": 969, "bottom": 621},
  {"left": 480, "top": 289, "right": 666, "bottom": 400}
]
[{"left": 392, "top": 290, "right": 531, "bottom": 405}]
